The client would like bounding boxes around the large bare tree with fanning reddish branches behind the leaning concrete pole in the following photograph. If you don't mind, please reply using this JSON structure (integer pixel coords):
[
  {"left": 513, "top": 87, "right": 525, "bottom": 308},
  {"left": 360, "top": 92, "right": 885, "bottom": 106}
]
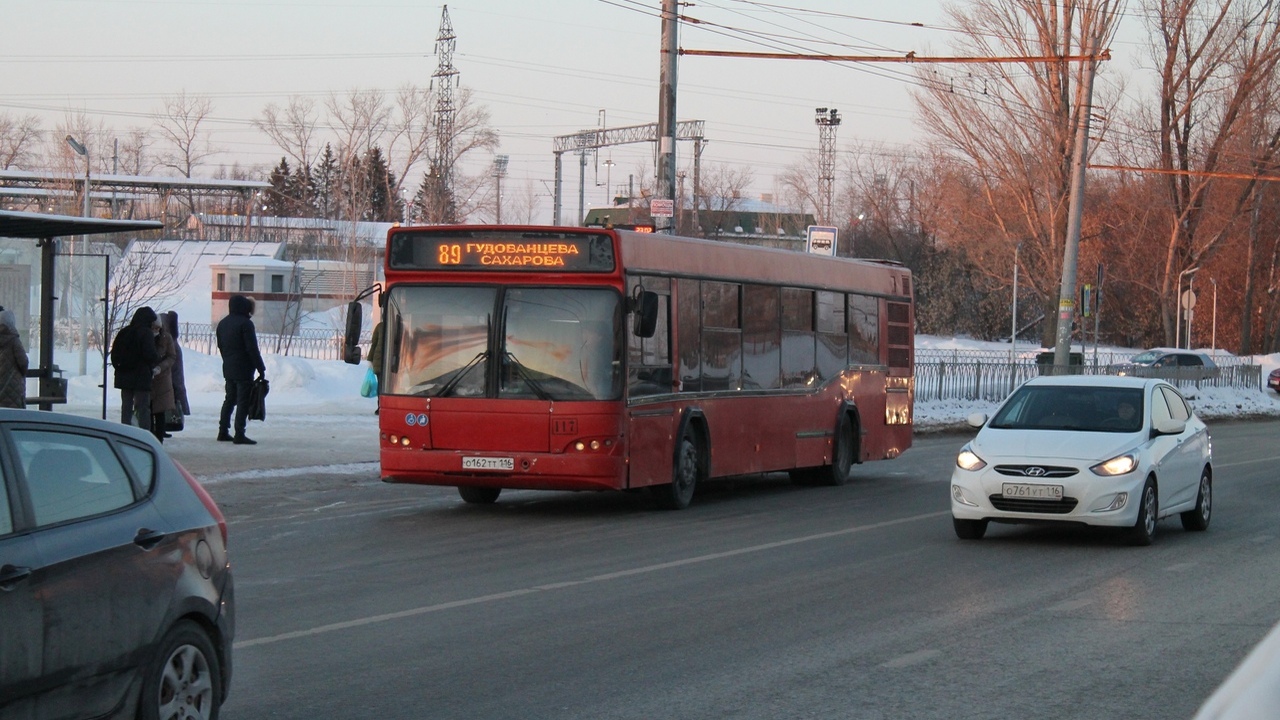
[{"left": 916, "top": 0, "right": 1121, "bottom": 345}]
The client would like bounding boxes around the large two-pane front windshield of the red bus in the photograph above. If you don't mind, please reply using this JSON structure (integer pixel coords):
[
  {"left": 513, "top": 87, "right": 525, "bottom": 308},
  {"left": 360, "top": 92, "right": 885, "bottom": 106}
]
[{"left": 383, "top": 284, "right": 622, "bottom": 401}]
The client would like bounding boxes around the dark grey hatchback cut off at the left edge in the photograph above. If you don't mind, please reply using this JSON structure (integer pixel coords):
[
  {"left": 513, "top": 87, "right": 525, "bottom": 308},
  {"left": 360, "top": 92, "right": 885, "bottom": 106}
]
[{"left": 0, "top": 410, "right": 236, "bottom": 720}]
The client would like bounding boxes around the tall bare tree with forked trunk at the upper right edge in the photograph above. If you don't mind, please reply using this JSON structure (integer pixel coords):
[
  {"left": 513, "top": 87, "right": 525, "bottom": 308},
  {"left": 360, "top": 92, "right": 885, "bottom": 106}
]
[{"left": 1139, "top": 0, "right": 1280, "bottom": 343}]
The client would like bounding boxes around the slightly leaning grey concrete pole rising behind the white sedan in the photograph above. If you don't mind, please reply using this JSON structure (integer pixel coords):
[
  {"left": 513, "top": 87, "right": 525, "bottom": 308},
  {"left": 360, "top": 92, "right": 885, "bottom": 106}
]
[{"left": 1053, "top": 37, "right": 1097, "bottom": 374}]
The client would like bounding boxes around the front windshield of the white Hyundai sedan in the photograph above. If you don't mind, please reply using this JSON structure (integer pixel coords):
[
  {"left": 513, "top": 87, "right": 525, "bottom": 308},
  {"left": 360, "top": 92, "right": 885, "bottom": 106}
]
[{"left": 991, "top": 386, "right": 1144, "bottom": 433}]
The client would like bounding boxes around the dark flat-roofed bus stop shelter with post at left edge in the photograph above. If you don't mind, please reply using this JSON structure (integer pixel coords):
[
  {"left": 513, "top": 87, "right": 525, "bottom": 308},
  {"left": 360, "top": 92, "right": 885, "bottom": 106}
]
[{"left": 0, "top": 210, "right": 164, "bottom": 410}]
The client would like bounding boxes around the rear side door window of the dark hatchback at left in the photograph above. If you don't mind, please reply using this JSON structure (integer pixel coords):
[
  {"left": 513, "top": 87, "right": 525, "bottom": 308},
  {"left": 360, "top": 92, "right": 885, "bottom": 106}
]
[{"left": 13, "top": 430, "right": 134, "bottom": 527}]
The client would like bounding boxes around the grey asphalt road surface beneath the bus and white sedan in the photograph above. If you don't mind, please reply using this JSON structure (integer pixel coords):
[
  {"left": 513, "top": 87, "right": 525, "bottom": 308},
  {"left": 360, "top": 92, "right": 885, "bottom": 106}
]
[{"left": 209, "top": 421, "right": 1280, "bottom": 720}]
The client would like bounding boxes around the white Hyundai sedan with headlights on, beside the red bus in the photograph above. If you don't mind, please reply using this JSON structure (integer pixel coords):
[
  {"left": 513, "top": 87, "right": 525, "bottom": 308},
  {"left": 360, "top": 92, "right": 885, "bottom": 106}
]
[{"left": 951, "top": 375, "right": 1213, "bottom": 544}]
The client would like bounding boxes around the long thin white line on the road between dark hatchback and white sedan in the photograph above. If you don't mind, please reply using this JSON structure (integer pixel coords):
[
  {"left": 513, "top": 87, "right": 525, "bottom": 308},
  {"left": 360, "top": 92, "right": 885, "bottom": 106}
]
[{"left": 234, "top": 510, "right": 951, "bottom": 650}]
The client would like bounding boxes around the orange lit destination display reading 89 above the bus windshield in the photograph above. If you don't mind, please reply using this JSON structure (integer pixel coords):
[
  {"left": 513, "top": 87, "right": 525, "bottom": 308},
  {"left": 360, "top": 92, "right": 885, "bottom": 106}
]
[{"left": 389, "top": 231, "right": 613, "bottom": 273}]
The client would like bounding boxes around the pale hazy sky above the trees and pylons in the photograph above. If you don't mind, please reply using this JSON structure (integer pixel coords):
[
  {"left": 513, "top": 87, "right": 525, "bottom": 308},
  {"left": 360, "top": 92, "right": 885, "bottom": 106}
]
[{"left": 0, "top": 0, "right": 1152, "bottom": 222}]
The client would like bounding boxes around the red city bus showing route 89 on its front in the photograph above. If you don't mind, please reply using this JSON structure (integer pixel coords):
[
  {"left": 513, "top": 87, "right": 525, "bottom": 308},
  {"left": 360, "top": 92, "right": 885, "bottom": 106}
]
[{"left": 347, "top": 225, "right": 914, "bottom": 509}]
